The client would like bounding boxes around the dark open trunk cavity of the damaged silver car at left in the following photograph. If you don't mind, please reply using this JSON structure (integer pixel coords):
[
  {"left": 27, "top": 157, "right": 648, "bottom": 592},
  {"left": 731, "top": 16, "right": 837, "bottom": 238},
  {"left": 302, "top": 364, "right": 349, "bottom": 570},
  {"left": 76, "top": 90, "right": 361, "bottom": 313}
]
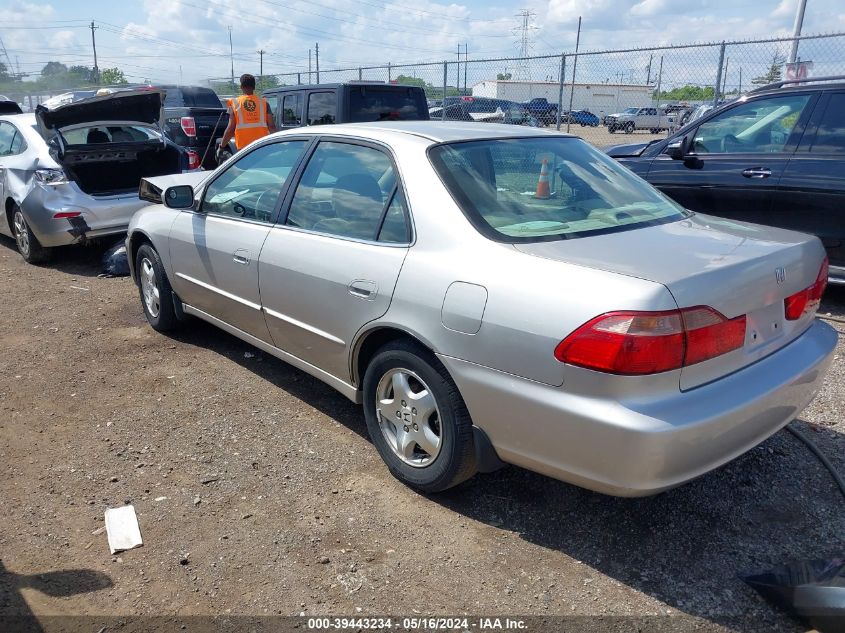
[{"left": 63, "top": 141, "right": 182, "bottom": 196}]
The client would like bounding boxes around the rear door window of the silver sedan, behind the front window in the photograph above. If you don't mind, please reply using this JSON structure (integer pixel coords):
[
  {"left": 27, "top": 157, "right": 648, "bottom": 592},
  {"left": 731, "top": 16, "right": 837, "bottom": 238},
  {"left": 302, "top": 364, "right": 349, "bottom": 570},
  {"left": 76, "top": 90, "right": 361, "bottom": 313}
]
[{"left": 286, "top": 142, "right": 396, "bottom": 240}]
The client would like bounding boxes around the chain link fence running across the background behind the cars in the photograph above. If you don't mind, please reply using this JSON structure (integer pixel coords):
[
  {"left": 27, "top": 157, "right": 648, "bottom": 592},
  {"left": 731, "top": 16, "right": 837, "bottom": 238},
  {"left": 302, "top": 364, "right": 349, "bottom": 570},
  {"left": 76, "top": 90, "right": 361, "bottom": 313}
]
[{"left": 209, "top": 33, "right": 845, "bottom": 146}]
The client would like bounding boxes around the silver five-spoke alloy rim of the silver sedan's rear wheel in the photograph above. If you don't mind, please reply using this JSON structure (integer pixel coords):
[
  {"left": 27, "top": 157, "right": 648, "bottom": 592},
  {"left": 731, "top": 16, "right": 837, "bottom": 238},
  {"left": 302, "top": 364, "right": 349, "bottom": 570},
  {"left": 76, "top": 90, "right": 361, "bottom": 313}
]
[{"left": 375, "top": 368, "right": 443, "bottom": 468}]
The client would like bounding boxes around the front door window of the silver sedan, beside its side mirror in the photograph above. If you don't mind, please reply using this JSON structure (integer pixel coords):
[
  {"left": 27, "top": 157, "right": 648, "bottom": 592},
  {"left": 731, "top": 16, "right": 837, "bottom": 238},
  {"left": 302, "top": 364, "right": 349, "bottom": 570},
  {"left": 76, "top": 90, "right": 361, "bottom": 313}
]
[{"left": 201, "top": 140, "right": 308, "bottom": 222}]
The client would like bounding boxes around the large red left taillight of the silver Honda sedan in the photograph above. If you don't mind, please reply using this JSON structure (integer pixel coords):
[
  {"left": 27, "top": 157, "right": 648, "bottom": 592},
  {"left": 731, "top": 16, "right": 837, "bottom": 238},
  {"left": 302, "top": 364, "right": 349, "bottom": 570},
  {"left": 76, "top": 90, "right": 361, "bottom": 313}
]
[{"left": 555, "top": 306, "right": 745, "bottom": 376}]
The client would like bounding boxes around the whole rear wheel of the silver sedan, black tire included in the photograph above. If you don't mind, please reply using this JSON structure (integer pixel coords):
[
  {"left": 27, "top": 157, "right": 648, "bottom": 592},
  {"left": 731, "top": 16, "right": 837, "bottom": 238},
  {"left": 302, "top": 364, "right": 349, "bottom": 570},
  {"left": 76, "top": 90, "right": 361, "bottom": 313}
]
[{"left": 363, "top": 342, "right": 476, "bottom": 493}]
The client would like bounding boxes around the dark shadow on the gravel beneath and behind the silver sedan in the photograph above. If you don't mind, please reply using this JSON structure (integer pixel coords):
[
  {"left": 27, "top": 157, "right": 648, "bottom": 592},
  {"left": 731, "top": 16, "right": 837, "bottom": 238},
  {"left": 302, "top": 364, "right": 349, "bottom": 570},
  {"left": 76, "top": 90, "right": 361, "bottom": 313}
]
[{"left": 166, "top": 320, "right": 845, "bottom": 631}]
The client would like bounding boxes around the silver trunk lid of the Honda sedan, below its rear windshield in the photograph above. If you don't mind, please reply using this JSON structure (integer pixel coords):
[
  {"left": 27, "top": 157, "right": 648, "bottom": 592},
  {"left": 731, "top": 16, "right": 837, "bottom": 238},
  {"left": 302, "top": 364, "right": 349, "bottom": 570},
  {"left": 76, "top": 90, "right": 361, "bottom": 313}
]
[{"left": 515, "top": 215, "right": 824, "bottom": 389}]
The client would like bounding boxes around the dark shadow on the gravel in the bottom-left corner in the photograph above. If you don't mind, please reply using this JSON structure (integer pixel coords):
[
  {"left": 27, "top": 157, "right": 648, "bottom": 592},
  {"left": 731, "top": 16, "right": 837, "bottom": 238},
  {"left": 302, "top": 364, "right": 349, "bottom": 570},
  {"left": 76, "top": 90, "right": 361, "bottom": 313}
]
[{"left": 0, "top": 560, "right": 114, "bottom": 633}]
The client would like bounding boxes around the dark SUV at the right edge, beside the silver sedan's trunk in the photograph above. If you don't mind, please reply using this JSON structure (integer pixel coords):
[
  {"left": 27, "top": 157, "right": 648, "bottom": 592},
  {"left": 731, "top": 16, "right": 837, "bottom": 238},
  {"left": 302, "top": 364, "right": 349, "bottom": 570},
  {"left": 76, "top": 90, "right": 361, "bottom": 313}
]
[{"left": 606, "top": 77, "right": 845, "bottom": 284}]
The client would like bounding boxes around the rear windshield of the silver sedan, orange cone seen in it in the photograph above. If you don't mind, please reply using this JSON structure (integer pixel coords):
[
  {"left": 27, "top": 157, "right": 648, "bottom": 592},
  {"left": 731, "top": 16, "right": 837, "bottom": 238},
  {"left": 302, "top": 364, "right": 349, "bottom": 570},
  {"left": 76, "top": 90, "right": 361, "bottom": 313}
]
[{"left": 429, "top": 136, "right": 688, "bottom": 243}]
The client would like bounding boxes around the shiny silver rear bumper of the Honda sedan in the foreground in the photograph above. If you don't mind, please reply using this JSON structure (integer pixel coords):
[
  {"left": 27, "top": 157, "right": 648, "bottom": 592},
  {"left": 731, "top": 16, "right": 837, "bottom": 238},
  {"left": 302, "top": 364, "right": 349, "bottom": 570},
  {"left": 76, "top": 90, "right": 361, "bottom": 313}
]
[{"left": 440, "top": 321, "right": 837, "bottom": 497}]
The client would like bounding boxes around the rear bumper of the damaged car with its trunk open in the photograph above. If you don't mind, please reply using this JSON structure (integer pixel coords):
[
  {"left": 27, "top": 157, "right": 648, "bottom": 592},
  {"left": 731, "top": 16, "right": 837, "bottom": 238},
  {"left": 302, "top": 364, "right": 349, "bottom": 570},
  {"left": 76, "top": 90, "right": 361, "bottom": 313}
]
[{"left": 21, "top": 183, "right": 148, "bottom": 248}]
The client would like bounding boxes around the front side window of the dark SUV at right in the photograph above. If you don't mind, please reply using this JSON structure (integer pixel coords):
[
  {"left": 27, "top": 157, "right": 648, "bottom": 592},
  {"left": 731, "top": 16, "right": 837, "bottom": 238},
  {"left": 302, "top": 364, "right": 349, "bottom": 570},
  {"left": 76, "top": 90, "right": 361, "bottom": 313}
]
[{"left": 693, "top": 95, "right": 810, "bottom": 154}]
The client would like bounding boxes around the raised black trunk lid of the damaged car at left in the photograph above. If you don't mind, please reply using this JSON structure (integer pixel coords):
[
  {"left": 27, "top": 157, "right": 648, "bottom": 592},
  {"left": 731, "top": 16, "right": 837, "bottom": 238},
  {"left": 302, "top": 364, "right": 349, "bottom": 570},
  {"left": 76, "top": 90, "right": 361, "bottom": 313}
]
[{"left": 35, "top": 89, "right": 164, "bottom": 138}]
